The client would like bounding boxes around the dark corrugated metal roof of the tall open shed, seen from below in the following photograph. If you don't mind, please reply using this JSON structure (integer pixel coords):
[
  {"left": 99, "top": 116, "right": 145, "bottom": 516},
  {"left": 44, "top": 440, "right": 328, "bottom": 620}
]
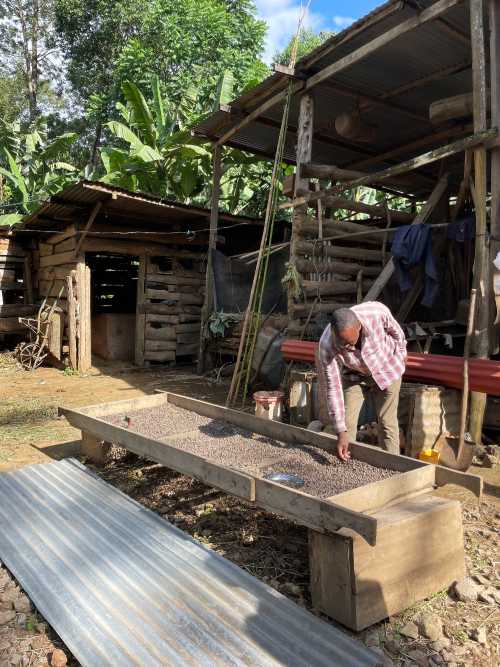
[{"left": 195, "top": 0, "right": 472, "bottom": 191}]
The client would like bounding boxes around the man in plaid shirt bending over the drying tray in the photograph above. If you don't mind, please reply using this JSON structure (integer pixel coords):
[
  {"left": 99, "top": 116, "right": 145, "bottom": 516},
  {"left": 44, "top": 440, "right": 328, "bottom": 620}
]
[{"left": 317, "top": 301, "right": 406, "bottom": 461}]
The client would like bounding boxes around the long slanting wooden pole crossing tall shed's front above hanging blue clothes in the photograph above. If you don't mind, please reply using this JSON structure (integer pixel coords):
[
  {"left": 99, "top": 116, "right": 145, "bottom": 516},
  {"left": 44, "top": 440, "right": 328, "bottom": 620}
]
[{"left": 281, "top": 128, "right": 498, "bottom": 208}]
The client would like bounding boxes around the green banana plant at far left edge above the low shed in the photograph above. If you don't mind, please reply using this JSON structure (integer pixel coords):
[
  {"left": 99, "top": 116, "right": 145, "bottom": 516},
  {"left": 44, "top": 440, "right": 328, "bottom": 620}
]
[{"left": 0, "top": 123, "right": 78, "bottom": 225}]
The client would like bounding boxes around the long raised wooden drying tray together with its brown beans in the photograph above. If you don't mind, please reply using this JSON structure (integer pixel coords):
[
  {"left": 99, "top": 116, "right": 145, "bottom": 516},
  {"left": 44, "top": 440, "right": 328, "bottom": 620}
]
[{"left": 60, "top": 393, "right": 480, "bottom": 545}]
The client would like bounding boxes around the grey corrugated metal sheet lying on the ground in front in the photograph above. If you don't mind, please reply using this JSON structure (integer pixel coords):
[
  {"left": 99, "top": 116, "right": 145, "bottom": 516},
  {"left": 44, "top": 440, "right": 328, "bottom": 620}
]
[{"left": 0, "top": 460, "right": 380, "bottom": 667}]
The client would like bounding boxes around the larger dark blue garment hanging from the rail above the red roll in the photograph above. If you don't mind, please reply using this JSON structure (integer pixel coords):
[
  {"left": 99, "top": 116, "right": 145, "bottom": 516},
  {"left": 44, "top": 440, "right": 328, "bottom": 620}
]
[{"left": 391, "top": 223, "right": 439, "bottom": 308}]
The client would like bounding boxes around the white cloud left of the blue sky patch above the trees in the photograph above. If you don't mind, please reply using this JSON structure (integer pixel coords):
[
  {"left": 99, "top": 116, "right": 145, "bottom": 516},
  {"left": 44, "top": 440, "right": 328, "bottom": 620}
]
[{"left": 255, "top": 0, "right": 325, "bottom": 63}]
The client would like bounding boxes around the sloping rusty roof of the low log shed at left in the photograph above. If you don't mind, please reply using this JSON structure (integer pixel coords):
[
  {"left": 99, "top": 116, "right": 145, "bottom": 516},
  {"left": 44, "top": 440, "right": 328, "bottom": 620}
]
[{"left": 14, "top": 180, "right": 261, "bottom": 233}]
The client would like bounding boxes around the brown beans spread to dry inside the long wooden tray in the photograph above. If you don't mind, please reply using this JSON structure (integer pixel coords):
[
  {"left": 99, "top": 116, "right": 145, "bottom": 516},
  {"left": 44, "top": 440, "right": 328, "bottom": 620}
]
[{"left": 104, "top": 406, "right": 397, "bottom": 498}]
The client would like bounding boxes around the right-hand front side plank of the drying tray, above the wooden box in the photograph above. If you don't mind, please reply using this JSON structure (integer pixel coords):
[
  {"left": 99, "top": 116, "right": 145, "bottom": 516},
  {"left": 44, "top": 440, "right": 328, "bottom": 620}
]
[{"left": 255, "top": 478, "right": 377, "bottom": 545}]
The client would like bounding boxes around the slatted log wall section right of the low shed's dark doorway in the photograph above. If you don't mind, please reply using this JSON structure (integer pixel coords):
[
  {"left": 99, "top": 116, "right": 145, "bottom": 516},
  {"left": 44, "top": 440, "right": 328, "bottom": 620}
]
[{"left": 141, "top": 253, "right": 205, "bottom": 363}]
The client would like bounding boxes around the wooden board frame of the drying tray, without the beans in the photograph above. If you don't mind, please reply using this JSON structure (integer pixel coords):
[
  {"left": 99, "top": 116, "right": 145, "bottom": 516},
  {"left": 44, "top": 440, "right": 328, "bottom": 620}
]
[{"left": 60, "top": 393, "right": 481, "bottom": 545}]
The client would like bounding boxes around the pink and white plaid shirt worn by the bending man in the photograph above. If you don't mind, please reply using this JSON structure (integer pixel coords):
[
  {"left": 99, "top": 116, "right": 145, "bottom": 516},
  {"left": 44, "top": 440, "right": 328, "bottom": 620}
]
[{"left": 319, "top": 301, "right": 406, "bottom": 433}]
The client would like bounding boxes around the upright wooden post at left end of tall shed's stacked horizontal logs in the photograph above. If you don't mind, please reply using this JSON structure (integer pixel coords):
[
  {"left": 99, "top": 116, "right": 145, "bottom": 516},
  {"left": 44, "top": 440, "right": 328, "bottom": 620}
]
[{"left": 288, "top": 93, "right": 319, "bottom": 325}]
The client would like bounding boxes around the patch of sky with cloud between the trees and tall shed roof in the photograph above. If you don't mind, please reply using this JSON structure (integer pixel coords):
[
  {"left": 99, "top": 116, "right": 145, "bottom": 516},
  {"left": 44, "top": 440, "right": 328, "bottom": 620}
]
[{"left": 254, "top": 0, "right": 384, "bottom": 62}]
